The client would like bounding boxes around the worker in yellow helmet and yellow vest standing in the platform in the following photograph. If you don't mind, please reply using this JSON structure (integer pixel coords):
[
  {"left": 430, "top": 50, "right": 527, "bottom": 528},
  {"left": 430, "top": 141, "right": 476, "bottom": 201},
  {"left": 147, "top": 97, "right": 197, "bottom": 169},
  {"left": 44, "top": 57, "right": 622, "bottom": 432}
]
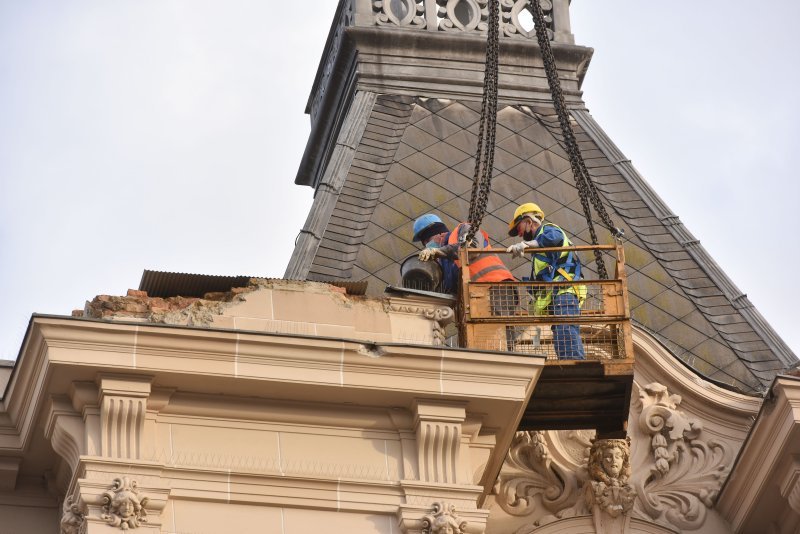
[{"left": 507, "top": 202, "right": 586, "bottom": 360}]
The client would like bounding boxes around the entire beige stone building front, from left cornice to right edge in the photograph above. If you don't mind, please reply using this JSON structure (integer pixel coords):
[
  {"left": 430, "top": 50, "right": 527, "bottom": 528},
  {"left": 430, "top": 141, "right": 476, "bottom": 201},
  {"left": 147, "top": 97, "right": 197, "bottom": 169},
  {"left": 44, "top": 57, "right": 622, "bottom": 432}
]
[{"left": 0, "top": 280, "right": 800, "bottom": 534}]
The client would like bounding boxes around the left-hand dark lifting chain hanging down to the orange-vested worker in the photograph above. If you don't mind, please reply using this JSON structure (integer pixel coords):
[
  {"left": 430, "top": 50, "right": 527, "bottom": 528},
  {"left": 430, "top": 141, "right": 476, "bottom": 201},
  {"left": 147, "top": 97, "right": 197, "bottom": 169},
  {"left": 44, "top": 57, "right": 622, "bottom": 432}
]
[{"left": 464, "top": 0, "right": 500, "bottom": 247}]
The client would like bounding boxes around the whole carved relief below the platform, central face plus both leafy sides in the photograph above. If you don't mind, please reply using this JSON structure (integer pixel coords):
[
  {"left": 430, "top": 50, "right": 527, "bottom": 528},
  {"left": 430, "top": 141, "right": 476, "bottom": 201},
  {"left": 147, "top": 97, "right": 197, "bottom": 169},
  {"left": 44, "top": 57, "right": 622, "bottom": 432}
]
[{"left": 495, "top": 383, "right": 733, "bottom": 534}]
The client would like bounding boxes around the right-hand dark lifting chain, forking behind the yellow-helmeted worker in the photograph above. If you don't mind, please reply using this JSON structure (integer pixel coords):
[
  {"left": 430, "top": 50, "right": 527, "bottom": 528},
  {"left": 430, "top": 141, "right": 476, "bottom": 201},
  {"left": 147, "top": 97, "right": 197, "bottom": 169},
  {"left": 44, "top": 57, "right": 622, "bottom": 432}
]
[{"left": 528, "top": 0, "right": 623, "bottom": 280}]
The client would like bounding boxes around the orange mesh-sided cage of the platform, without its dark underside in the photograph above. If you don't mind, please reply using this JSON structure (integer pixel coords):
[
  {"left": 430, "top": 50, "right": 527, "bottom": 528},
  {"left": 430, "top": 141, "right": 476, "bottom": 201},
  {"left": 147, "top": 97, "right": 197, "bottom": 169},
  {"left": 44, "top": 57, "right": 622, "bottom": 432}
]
[{"left": 461, "top": 247, "right": 632, "bottom": 360}]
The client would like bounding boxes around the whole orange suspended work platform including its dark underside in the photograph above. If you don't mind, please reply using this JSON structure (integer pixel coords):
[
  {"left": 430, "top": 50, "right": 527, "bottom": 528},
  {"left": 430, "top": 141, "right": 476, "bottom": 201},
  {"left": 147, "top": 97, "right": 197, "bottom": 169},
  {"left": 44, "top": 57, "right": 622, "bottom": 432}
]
[{"left": 458, "top": 245, "right": 634, "bottom": 436}]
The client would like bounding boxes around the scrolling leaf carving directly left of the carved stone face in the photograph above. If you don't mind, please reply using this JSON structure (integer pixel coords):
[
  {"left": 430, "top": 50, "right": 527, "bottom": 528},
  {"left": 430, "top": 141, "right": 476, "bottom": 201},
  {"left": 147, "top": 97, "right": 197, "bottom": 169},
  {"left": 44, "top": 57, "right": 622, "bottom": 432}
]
[{"left": 497, "top": 431, "right": 578, "bottom": 516}]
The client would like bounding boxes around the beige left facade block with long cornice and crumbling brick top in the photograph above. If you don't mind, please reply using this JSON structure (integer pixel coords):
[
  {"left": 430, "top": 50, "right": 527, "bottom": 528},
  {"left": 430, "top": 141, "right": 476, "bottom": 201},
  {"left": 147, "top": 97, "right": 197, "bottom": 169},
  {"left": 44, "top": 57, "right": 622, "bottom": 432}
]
[{"left": 0, "top": 280, "right": 543, "bottom": 534}]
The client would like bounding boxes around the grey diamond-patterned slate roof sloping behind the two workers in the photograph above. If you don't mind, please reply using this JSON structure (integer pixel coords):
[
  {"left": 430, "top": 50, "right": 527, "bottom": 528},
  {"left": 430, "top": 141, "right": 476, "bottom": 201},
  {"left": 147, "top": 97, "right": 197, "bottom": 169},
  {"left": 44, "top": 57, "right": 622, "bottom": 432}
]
[{"left": 292, "top": 95, "right": 796, "bottom": 393}]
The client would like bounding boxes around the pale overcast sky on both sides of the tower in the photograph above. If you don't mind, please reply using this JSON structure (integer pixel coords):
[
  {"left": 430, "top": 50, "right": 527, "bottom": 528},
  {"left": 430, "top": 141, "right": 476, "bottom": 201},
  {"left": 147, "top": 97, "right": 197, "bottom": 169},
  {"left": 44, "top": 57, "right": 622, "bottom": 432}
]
[{"left": 0, "top": 0, "right": 800, "bottom": 359}]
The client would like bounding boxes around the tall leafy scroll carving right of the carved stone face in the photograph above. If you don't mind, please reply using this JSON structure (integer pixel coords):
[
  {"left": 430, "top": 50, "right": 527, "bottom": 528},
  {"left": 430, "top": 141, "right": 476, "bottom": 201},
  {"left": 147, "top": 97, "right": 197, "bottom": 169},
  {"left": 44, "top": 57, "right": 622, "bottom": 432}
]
[{"left": 632, "top": 382, "right": 730, "bottom": 530}]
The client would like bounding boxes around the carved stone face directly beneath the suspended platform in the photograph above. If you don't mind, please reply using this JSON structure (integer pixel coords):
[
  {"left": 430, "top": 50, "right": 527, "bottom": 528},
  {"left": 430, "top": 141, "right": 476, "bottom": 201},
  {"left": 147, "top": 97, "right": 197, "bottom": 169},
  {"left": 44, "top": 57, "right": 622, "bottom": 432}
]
[{"left": 584, "top": 438, "right": 636, "bottom": 518}]
